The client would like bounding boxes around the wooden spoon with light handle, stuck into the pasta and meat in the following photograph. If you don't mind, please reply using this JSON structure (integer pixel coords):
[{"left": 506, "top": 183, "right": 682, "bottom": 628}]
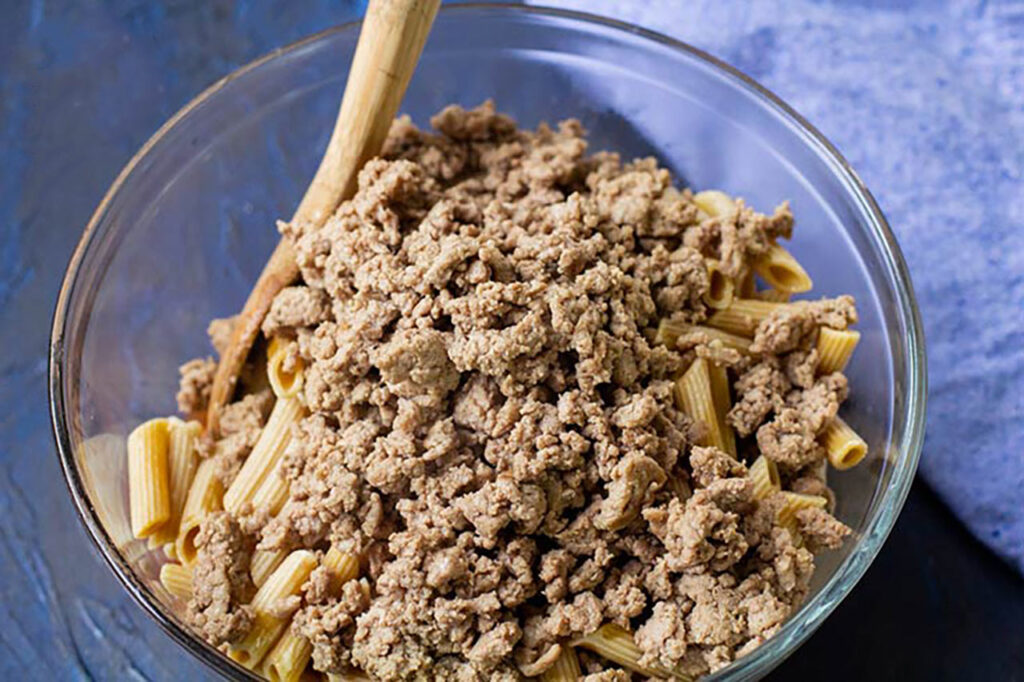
[{"left": 206, "top": 0, "right": 440, "bottom": 435}]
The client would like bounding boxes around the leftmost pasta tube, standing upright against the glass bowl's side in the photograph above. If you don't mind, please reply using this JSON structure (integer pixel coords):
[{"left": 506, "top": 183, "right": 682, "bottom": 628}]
[{"left": 128, "top": 419, "right": 171, "bottom": 538}]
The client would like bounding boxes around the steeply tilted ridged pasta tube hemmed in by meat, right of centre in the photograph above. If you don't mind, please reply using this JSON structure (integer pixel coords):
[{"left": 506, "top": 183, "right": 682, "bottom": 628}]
[{"left": 676, "top": 357, "right": 736, "bottom": 457}]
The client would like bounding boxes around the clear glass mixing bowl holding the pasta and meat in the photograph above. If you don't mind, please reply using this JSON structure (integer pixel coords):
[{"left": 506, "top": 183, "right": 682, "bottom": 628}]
[{"left": 49, "top": 5, "right": 925, "bottom": 680}]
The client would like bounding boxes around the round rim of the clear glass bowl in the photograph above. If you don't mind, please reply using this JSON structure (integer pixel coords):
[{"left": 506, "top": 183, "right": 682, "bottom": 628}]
[{"left": 47, "top": 2, "right": 928, "bottom": 680}]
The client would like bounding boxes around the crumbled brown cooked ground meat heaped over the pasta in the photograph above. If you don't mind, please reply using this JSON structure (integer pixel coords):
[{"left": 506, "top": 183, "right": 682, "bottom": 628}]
[{"left": 181, "top": 99, "right": 856, "bottom": 682}]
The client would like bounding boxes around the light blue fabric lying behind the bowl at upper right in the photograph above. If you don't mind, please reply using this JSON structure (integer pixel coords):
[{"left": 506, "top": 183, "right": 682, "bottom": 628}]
[{"left": 544, "top": 0, "right": 1024, "bottom": 572}]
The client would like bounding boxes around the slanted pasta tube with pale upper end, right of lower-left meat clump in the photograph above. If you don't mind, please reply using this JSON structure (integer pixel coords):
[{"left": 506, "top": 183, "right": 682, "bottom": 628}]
[{"left": 227, "top": 550, "right": 316, "bottom": 670}]
